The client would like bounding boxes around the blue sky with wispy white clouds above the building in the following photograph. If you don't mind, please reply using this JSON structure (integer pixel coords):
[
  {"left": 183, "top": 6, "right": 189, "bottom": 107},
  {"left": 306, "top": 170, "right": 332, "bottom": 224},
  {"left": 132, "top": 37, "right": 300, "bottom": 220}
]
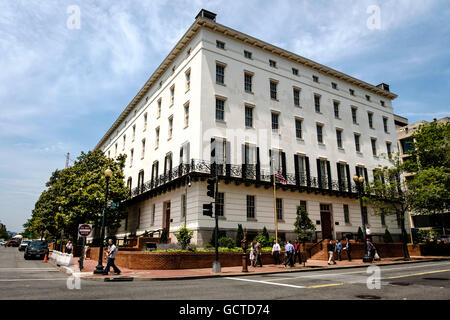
[{"left": 0, "top": 0, "right": 450, "bottom": 231}]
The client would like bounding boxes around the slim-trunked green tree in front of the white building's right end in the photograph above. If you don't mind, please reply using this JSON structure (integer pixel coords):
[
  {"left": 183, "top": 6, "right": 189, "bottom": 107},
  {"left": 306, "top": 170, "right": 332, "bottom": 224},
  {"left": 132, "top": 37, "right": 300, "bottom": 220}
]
[{"left": 364, "top": 156, "right": 412, "bottom": 260}]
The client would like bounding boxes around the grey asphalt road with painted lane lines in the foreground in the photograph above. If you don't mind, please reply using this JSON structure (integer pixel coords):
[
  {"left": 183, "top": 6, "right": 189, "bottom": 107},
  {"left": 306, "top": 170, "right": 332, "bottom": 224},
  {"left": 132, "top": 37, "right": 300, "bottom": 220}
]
[{"left": 0, "top": 247, "right": 450, "bottom": 300}]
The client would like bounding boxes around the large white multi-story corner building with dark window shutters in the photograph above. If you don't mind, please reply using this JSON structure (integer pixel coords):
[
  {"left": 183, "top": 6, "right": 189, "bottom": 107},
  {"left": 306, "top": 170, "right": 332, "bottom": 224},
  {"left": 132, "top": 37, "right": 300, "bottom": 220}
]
[{"left": 96, "top": 10, "right": 408, "bottom": 244}]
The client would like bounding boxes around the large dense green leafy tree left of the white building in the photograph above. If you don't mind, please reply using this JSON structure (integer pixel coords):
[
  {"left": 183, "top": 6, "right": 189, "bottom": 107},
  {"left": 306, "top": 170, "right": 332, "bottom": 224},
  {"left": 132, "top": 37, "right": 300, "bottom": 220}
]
[{"left": 24, "top": 150, "right": 129, "bottom": 239}]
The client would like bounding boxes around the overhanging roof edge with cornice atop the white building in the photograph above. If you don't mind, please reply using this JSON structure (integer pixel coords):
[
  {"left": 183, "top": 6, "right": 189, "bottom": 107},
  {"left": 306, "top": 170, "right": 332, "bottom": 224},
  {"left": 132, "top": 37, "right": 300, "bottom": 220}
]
[{"left": 95, "top": 9, "right": 397, "bottom": 149}]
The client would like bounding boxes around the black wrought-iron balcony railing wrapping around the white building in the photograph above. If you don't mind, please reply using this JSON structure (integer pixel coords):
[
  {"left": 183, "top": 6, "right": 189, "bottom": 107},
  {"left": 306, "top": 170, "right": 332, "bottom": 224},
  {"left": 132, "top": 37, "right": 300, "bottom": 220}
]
[{"left": 131, "top": 159, "right": 357, "bottom": 198}]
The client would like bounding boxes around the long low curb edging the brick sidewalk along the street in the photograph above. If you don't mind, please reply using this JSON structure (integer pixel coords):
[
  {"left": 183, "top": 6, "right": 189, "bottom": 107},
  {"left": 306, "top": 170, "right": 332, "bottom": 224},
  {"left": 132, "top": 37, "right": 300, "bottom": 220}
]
[{"left": 74, "top": 258, "right": 450, "bottom": 282}]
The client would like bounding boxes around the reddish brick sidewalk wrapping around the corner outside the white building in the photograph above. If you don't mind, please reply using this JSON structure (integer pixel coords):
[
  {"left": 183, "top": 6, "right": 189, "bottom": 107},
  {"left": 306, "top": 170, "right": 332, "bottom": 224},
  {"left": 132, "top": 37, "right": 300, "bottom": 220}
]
[{"left": 47, "top": 256, "right": 450, "bottom": 281}]
